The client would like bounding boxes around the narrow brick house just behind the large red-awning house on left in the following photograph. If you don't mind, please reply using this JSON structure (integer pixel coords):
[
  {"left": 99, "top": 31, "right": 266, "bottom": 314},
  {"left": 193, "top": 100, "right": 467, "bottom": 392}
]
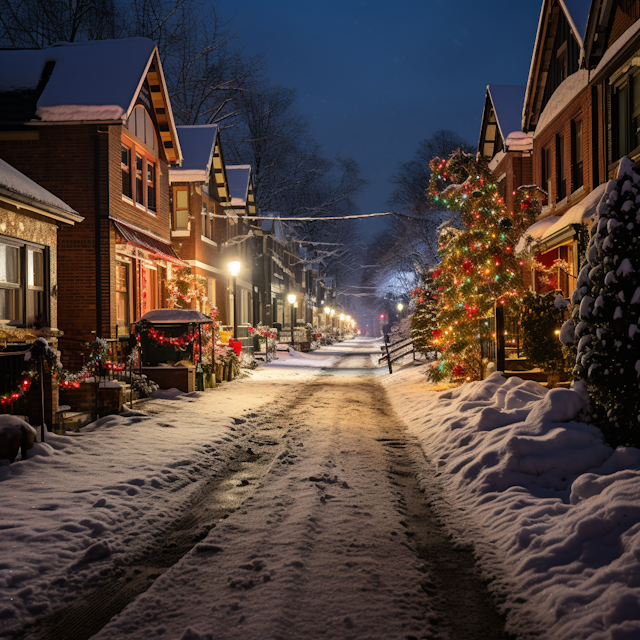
[{"left": 169, "top": 124, "right": 235, "bottom": 324}]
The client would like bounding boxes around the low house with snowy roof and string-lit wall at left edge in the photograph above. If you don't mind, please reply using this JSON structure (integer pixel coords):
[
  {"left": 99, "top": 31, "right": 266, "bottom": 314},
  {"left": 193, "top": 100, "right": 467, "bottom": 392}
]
[{"left": 0, "top": 155, "right": 82, "bottom": 424}]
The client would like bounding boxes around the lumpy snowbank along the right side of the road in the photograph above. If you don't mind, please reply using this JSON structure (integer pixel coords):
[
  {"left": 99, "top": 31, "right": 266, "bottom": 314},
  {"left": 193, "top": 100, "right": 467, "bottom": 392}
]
[{"left": 387, "top": 367, "right": 640, "bottom": 640}]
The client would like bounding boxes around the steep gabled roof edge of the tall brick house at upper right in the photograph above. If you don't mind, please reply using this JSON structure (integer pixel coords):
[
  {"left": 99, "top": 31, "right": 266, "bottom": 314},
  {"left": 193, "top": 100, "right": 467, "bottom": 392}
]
[{"left": 522, "top": 0, "right": 591, "bottom": 131}]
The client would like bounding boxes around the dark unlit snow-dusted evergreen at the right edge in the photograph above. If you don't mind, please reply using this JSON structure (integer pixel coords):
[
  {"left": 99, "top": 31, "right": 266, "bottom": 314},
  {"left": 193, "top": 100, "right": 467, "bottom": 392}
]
[{"left": 560, "top": 158, "right": 640, "bottom": 446}]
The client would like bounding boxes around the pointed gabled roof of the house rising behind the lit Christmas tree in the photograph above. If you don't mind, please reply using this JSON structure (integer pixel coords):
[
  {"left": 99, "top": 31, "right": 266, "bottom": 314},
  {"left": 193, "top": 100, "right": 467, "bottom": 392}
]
[{"left": 478, "top": 84, "right": 528, "bottom": 158}]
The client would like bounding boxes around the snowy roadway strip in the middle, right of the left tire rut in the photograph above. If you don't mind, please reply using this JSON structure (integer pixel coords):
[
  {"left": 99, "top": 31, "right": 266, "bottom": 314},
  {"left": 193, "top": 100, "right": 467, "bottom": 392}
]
[{"left": 87, "top": 343, "right": 504, "bottom": 640}]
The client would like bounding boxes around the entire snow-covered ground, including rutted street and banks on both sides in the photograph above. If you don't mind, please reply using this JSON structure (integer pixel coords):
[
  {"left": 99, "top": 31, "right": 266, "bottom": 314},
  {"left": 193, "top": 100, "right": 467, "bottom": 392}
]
[{"left": 0, "top": 339, "right": 640, "bottom": 640}]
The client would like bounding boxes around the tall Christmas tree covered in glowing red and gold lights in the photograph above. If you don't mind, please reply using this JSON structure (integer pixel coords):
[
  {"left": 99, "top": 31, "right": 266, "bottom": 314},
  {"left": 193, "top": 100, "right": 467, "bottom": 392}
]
[{"left": 429, "top": 151, "right": 538, "bottom": 380}]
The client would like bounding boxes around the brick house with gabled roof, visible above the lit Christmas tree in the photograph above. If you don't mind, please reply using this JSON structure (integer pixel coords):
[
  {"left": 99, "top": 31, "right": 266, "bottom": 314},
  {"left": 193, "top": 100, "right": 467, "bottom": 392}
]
[{"left": 478, "top": 85, "right": 533, "bottom": 212}]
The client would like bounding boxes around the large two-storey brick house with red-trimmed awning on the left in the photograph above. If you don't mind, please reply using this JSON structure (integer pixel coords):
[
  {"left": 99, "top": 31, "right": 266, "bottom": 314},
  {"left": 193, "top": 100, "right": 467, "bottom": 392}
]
[{"left": 0, "top": 38, "right": 183, "bottom": 364}]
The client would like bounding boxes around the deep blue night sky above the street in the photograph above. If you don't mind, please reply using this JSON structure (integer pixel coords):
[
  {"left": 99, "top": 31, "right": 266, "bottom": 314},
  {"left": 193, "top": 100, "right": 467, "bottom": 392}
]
[{"left": 219, "top": 0, "right": 542, "bottom": 238}]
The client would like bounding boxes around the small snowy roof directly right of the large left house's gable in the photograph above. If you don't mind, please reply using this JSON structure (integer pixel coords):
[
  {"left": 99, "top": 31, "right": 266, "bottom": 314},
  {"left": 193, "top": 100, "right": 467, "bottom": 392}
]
[{"left": 169, "top": 124, "right": 219, "bottom": 182}]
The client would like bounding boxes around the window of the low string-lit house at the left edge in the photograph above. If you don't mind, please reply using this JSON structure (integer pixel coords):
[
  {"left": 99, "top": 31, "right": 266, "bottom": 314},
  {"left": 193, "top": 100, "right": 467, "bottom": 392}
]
[{"left": 0, "top": 240, "right": 49, "bottom": 327}]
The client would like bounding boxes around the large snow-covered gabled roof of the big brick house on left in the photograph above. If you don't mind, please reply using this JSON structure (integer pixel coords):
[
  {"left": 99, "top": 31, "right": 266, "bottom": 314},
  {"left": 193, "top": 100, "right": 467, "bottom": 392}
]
[{"left": 0, "top": 38, "right": 182, "bottom": 162}]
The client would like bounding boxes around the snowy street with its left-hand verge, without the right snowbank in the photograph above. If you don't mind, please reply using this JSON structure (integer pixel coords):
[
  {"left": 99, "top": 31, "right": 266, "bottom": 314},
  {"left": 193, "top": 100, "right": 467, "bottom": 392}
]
[{"left": 2, "top": 340, "right": 504, "bottom": 638}]
